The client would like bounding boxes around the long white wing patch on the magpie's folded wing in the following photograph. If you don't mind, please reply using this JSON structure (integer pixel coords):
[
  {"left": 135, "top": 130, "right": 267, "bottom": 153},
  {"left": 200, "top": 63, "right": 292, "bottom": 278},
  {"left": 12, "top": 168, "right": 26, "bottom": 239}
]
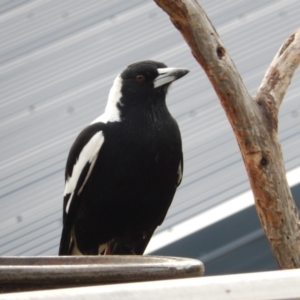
[{"left": 64, "top": 131, "right": 104, "bottom": 213}]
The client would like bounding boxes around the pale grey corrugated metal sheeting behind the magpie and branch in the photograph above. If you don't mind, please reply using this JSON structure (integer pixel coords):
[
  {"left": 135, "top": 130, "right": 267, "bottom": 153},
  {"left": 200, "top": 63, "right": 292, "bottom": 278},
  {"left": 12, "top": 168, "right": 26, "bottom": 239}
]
[{"left": 0, "top": 0, "right": 300, "bottom": 255}]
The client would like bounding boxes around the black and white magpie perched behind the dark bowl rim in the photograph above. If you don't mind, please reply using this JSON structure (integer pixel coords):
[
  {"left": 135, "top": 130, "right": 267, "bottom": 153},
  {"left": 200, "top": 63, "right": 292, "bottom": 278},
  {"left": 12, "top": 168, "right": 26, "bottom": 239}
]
[{"left": 59, "top": 60, "right": 189, "bottom": 255}]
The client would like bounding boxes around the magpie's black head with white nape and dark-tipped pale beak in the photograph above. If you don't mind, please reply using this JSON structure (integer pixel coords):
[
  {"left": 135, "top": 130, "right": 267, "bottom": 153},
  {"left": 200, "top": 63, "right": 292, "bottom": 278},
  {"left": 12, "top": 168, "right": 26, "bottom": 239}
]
[{"left": 102, "top": 60, "right": 189, "bottom": 121}]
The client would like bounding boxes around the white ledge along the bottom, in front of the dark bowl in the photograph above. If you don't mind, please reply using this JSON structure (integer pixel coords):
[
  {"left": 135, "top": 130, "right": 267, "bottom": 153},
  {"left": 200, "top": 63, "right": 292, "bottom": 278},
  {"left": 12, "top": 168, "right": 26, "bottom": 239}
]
[{"left": 0, "top": 270, "right": 300, "bottom": 300}]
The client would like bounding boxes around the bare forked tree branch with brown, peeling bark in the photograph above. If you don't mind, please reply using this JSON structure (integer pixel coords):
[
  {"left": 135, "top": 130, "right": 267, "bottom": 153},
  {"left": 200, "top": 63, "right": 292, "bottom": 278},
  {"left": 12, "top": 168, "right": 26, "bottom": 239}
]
[{"left": 155, "top": 0, "right": 300, "bottom": 269}]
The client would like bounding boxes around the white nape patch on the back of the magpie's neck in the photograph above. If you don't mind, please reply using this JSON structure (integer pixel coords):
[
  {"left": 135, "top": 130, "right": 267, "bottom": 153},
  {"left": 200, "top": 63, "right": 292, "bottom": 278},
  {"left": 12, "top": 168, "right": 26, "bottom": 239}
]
[{"left": 91, "top": 75, "right": 122, "bottom": 124}]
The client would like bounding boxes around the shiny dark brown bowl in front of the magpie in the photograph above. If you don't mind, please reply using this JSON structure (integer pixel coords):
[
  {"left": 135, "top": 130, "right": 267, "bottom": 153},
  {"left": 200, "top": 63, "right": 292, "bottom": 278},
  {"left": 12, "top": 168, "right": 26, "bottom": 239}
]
[{"left": 0, "top": 255, "right": 204, "bottom": 293}]
